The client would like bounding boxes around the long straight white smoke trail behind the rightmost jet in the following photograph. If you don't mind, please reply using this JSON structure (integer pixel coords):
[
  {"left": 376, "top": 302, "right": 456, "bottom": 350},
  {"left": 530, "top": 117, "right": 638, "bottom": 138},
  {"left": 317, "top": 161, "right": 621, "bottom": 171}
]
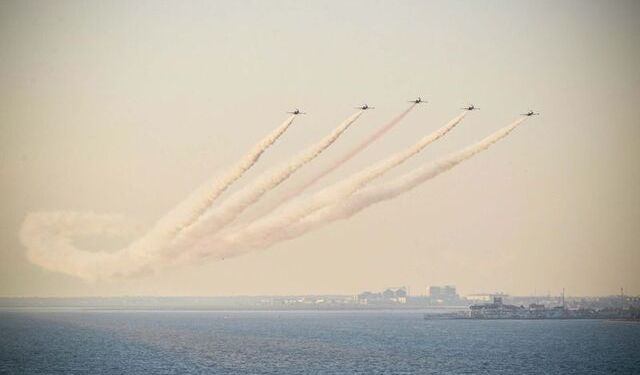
[{"left": 214, "top": 117, "right": 526, "bottom": 257}]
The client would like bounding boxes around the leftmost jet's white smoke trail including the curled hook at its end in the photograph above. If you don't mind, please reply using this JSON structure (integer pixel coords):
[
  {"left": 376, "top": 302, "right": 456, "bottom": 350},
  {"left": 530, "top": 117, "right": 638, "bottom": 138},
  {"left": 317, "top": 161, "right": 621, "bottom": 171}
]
[{"left": 20, "top": 116, "right": 295, "bottom": 279}]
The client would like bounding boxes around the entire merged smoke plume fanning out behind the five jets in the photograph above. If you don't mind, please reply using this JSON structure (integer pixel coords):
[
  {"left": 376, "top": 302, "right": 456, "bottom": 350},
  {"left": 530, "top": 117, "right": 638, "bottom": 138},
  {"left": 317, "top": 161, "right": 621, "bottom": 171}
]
[{"left": 20, "top": 107, "right": 526, "bottom": 280}]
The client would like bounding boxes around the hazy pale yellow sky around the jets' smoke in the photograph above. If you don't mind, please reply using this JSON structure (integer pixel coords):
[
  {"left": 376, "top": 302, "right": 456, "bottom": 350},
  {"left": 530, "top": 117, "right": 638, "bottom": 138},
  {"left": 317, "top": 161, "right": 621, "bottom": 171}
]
[{"left": 0, "top": 1, "right": 640, "bottom": 296}]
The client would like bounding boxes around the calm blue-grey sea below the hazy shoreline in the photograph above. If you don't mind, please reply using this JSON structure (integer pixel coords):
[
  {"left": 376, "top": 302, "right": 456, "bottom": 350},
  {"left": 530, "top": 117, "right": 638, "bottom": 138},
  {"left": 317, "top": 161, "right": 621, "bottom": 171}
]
[{"left": 0, "top": 311, "right": 640, "bottom": 374}]
